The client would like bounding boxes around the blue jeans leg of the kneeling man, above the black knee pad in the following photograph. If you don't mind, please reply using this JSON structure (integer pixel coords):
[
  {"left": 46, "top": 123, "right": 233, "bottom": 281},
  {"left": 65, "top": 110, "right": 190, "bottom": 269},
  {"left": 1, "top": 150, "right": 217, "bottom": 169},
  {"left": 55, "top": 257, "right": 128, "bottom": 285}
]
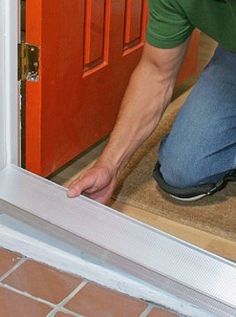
[{"left": 159, "top": 47, "right": 236, "bottom": 188}]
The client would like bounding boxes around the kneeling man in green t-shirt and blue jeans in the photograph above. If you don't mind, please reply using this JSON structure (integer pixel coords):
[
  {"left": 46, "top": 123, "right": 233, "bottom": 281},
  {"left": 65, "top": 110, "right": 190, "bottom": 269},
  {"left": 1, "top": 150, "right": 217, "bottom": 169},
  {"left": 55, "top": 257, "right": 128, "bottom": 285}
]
[{"left": 68, "top": 0, "right": 236, "bottom": 203}]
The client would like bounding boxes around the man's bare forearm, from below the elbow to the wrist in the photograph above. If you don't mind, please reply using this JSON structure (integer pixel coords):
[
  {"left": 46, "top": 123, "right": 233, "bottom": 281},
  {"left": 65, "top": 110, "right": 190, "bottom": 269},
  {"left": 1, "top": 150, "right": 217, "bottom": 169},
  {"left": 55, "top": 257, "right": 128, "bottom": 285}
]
[{"left": 99, "top": 61, "right": 175, "bottom": 172}]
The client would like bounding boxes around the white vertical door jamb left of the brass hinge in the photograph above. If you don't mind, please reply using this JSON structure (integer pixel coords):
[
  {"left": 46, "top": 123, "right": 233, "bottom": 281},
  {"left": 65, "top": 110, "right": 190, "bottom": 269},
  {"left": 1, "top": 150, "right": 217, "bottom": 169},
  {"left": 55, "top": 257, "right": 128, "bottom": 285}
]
[{"left": 0, "top": 0, "right": 20, "bottom": 168}]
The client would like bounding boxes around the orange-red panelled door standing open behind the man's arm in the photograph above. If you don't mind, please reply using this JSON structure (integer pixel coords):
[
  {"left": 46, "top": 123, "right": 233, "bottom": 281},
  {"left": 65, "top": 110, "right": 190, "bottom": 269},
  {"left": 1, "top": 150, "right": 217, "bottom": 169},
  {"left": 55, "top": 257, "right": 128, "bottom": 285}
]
[{"left": 26, "top": 0, "right": 199, "bottom": 176}]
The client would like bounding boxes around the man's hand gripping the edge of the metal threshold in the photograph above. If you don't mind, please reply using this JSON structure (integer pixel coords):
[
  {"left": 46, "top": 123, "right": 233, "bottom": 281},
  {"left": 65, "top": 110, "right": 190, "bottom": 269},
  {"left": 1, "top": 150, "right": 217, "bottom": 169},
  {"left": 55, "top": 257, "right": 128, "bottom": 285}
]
[{"left": 68, "top": 163, "right": 117, "bottom": 204}]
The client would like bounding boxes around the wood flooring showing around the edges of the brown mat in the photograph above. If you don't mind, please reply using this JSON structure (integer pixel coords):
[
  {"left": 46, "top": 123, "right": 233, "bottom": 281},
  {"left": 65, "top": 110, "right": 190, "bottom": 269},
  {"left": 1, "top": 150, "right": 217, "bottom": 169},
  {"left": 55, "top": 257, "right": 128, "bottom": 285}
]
[{"left": 51, "top": 34, "right": 236, "bottom": 261}]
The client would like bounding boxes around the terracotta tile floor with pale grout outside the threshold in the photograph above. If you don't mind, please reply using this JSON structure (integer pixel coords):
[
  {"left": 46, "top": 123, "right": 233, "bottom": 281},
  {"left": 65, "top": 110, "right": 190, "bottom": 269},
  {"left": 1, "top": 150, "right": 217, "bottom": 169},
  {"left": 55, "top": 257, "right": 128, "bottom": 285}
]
[{"left": 0, "top": 248, "right": 180, "bottom": 317}]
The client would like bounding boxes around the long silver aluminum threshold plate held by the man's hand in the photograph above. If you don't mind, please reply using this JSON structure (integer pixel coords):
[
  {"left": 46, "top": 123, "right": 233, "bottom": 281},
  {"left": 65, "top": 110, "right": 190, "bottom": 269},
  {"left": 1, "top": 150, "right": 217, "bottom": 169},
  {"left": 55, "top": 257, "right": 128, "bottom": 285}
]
[{"left": 0, "top": 165, "right": 236, "bottom": 317}]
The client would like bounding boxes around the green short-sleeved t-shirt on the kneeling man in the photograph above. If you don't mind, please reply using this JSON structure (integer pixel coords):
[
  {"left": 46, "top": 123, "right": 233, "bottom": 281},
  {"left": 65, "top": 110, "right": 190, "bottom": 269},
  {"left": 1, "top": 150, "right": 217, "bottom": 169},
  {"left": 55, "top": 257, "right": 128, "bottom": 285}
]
[{"left": 147, "top": 0, "right": 236, "bottom": 52}]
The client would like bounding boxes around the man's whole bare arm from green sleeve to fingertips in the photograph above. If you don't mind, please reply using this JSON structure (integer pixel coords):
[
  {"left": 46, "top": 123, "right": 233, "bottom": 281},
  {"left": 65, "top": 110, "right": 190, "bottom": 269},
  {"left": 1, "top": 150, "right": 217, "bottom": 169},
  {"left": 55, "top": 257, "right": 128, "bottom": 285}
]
[{"left": 68, "top": 41, "right": 188, "bottom": 203}]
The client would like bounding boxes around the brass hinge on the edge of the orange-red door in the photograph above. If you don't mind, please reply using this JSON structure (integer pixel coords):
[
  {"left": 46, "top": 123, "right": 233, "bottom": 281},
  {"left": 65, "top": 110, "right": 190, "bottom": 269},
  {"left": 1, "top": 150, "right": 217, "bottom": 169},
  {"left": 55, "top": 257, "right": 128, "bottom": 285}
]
[{"left": 18, "top": 42, "right": 39, "bottom": 81}]
